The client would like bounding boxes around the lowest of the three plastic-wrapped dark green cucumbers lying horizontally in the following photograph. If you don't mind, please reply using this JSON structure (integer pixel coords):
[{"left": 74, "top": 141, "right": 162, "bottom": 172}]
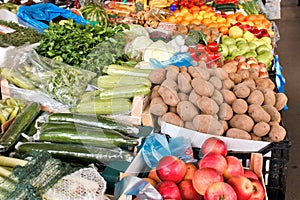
[{"left": 17, "top": 142, "right": 132, "bottom": 164}]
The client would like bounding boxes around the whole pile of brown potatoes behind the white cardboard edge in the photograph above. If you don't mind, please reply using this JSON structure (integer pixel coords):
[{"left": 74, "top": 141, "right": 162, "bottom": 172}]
[{"left": 149, "top": 59, "right": 287, "bottom": 142}]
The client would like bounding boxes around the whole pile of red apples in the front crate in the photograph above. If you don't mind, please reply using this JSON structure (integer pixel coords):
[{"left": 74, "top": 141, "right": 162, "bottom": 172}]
[{"left": 145, "top": 137, "right": 265, "bottom": 200}]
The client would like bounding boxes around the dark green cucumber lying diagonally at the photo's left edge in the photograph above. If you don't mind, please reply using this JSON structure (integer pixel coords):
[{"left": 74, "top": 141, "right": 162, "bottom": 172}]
[{"left": 0, "top": 102, "right": 41, "bottom": 152}]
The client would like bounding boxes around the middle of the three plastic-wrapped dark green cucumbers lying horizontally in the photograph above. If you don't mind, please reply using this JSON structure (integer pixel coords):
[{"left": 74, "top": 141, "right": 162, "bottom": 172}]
[{"left": 39, "top": 128, "right": 139, "bottom": 148}]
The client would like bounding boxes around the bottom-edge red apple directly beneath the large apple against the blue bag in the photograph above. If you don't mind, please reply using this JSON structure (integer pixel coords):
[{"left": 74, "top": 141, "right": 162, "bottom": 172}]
[{"left": 156, "top": 181, "right": 181, "bottom": 200}]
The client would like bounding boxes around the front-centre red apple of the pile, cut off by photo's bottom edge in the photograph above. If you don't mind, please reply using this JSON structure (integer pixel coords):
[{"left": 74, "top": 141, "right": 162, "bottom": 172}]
[{"left": 204, "top": 182, "right": 238, "bottom": 200}]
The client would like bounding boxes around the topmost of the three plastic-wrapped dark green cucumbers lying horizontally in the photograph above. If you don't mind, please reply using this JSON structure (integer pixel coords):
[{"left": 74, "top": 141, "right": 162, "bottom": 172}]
[{"left": 48, "top": 113, "right": 139, "bottom": 135}]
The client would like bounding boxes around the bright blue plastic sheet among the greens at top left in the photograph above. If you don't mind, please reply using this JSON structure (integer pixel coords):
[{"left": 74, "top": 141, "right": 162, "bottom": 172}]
[{"left": 17, "top": 3, "right": 88, "bottom": 32}]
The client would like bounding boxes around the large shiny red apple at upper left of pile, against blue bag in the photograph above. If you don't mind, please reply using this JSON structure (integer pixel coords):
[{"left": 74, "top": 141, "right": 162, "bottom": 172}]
[{"left": 156, "top": 156, "right": 186, "bottom": 183}]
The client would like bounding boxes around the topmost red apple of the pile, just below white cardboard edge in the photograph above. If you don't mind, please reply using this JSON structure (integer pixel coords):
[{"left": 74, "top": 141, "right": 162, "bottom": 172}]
[{"left": 201, "top": 137, "right": 227, "bottom": 156}]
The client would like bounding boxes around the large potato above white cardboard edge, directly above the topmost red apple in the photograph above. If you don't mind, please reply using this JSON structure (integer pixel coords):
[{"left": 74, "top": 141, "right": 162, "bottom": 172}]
[{"left": 193, "top": 114, "right": 224, "bottom": 135}]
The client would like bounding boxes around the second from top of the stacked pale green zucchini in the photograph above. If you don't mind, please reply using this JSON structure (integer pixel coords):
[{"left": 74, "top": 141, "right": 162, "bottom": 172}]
[{"left": 97, "top": 75, "right": 151, "bottom": 89}]
